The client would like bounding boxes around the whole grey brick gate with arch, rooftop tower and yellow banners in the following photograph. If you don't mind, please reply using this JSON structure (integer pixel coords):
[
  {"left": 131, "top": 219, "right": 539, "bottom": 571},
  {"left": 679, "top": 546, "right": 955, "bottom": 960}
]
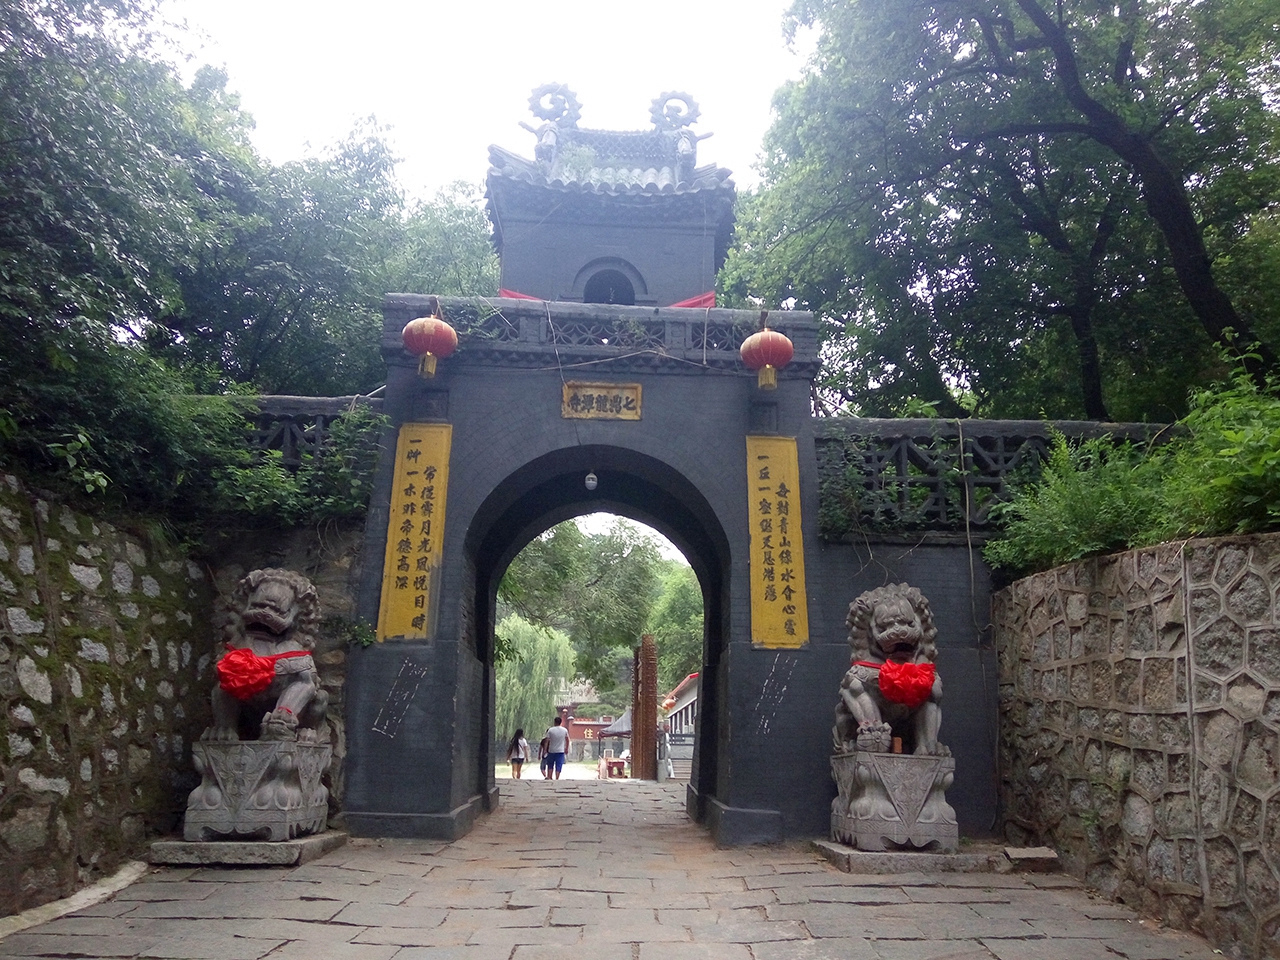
[{"left": 335, "top": 91, "right": 996, "bottom": 845}]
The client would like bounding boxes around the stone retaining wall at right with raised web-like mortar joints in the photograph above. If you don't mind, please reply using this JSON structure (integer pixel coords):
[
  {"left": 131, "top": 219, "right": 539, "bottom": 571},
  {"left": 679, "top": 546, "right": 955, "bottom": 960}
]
[{"left": 992, "top": 534, "right": 1280, "bottom": 957}]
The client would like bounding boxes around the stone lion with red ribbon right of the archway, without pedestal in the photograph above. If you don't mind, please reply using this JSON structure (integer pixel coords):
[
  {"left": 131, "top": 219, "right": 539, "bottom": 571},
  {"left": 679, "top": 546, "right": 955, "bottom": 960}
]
[{"left": 832, "top": 584, "right": 951, "bottom": 756}]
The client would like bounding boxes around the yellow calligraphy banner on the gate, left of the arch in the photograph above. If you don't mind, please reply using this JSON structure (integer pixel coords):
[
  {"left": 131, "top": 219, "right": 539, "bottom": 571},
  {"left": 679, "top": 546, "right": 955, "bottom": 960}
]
[{"left": 378, "top": 424, "right": 453, "bottom": 640}]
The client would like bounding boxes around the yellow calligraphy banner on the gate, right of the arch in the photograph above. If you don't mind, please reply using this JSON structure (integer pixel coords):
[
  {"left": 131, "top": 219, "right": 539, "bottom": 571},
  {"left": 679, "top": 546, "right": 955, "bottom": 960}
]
[{"left": 746, "top": 436, "right": 809, "bottom": 648}]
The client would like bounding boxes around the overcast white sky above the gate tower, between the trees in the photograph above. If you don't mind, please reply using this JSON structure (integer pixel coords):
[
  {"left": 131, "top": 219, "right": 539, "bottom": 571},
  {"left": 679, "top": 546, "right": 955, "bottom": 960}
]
[{"left": 165, "top": 0, "right": 805, "bottom": 197}]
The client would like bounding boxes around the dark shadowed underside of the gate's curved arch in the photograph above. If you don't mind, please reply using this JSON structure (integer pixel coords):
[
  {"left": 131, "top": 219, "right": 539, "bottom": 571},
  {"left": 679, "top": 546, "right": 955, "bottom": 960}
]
[{"left": 467, "top": 445, "right": 731, "bottom": 782}]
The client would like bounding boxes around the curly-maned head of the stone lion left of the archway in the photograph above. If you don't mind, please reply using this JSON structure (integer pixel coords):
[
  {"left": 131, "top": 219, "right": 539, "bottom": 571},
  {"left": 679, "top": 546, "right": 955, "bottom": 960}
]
[{"left": 223, "top": 567, "right": 320, "bottom": 650}]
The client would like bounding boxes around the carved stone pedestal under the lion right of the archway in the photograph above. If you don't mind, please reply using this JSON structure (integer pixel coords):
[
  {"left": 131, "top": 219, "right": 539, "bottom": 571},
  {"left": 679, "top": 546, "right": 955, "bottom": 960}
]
[{"left": 831, "top": 750, "right": 960, "bottom": 852}]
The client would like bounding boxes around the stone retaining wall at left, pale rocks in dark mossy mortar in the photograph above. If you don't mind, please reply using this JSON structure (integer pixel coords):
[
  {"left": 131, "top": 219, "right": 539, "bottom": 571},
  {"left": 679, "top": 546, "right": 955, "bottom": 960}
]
[{"left": 0, "top": 475, "right": 214, "bottom": 915}]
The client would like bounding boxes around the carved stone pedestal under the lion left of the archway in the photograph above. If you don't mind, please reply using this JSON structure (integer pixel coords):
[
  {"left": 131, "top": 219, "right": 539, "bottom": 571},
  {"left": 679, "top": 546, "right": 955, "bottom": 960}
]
[{"left": 182, "top": 740, "right": 333, "bottom": 841}]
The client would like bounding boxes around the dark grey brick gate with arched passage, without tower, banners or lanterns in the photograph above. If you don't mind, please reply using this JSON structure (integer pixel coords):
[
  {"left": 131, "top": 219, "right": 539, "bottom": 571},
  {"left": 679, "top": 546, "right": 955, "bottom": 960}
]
[{"left": 344, "top": 296, "right": 996, "bottom": 845}]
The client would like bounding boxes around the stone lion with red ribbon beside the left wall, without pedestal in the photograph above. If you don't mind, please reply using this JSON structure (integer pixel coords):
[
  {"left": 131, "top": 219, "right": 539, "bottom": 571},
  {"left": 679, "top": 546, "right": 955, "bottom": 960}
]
[{"left": 201, "top": 568, "right": 329, "bottom": 741}]
